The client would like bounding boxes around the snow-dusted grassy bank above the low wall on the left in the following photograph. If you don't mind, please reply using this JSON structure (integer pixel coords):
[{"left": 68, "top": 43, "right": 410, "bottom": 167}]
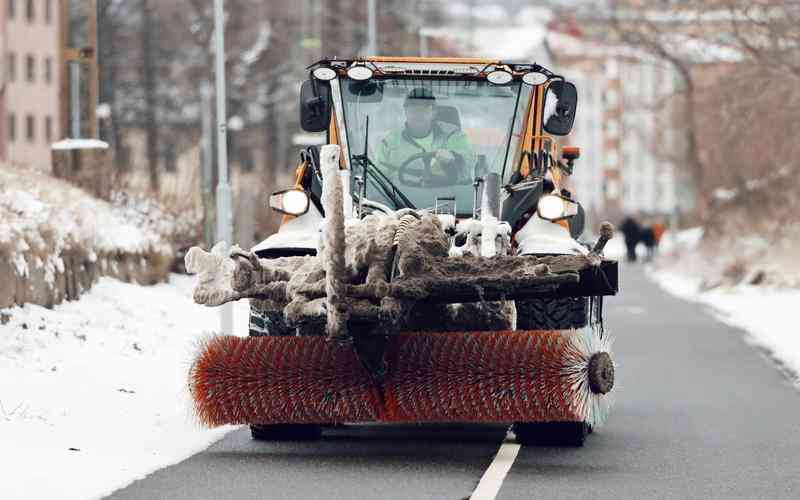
[{"left": 0, "top": 162, "right": 200, "bottom": 306}]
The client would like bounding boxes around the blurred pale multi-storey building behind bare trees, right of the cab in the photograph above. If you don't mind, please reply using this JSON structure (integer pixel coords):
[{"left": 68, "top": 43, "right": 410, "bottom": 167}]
[{"left": 547, "top": 26, "right": 681, "bottom": 220}]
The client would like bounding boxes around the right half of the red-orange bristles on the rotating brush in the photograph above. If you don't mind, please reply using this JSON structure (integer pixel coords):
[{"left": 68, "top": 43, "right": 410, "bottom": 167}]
[{"left": 384, "top": 331, "right": 581, "bottom": 422}]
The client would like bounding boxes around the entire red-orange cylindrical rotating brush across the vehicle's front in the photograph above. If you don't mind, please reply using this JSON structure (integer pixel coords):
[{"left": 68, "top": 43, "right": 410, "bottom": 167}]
[{"left": 189, "top": 329, "right": 613, "bottom": 426}]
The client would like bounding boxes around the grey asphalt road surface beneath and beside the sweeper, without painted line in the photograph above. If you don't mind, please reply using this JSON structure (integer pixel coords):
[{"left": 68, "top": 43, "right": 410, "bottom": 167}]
[{"left": 104, "top": 267, "right": 800, "bottom": 500}]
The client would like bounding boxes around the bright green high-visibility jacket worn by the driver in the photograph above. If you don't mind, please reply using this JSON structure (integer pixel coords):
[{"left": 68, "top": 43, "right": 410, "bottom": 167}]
[{"left": 376, "top": 121, "right": 475, "bottom": 181}]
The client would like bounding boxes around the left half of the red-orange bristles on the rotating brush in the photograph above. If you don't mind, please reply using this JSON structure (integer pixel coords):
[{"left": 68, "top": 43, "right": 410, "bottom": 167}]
[{"left": 189, "top": 336, "right": 381, "bottom": 427}]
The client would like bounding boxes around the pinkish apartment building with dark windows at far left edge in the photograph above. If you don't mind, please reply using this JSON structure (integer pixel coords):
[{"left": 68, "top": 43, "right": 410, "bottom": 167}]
[{"left": 0, "top": 0, "right": 62, "bottom": 172}]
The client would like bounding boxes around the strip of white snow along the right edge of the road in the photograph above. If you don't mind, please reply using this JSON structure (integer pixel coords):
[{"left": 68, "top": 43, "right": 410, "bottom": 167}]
[{"left": 649, "top": 258, "right": 800, "bottom": 382}]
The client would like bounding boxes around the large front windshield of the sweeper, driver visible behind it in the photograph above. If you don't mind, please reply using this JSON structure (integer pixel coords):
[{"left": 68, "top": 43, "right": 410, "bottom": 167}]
[{"left": 341, "top": 78, "right": 531, "bottom": 214}]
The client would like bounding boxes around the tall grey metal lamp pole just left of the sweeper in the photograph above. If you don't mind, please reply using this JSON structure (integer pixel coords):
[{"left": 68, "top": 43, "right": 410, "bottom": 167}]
[{"left": 214, "top": 0, "right": 233, "bottom": 335}]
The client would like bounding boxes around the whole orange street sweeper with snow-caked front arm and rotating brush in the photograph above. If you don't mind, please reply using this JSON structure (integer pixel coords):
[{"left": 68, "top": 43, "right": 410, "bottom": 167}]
[{"left": 186, "top": 57, "right": 618, "bottom": 446}]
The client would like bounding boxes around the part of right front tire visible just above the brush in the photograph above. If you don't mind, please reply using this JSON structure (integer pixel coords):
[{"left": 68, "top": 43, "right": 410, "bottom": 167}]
[{"left": 516, "top": 297, "right": 588, "bottom": 330}]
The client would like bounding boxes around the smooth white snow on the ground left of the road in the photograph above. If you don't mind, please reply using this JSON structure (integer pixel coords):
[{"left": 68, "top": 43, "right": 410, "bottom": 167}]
[{"left": 0, "top": 274, "right": 248, "bottom": 500}]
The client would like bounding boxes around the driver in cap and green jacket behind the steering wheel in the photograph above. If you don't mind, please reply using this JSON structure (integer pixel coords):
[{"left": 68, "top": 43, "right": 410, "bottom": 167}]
[{"left": 377, "top": 87, "right": 475, "bottom": 182}]
